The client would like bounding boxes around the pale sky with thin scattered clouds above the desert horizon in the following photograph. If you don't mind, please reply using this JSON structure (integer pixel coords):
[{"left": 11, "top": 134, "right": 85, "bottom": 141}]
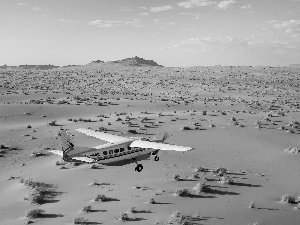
[{"left": 0, "top": 0, "right": 300, "bottom": 67}]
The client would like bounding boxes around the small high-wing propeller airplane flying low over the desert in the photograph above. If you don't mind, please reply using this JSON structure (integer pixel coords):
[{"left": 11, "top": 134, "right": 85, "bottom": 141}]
[{"left": 50, "top": 128, "right": 193, "bottom": 172}]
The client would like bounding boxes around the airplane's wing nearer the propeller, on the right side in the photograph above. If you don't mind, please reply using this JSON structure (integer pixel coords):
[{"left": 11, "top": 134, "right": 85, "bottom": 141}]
[{"left": 130, "top": 140, "right": 193, "bottom": 152}]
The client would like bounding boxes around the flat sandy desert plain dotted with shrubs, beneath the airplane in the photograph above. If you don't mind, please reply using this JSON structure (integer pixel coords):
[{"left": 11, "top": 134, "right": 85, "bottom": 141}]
[{"left": 0, "top": 63, "right": 300, "bottom": 225}]
